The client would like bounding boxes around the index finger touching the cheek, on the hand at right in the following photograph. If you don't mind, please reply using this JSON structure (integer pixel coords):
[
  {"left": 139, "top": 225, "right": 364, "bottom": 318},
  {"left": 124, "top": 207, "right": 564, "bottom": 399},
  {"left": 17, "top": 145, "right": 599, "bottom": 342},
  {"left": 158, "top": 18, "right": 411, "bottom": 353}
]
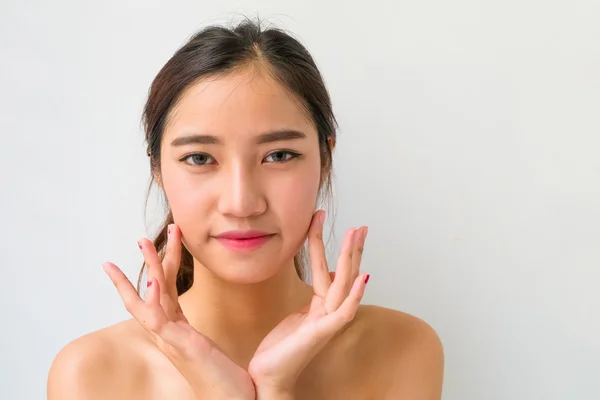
[{"left": 308, "top": 210, "right": 331, "bottom": 298}]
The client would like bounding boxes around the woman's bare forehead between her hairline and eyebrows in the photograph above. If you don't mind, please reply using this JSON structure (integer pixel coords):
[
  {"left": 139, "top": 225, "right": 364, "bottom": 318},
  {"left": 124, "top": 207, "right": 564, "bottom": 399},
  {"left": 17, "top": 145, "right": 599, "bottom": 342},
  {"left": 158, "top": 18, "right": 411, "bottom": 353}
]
[{"left": 165, "top": 68, "right": 316, "bottom": 136}]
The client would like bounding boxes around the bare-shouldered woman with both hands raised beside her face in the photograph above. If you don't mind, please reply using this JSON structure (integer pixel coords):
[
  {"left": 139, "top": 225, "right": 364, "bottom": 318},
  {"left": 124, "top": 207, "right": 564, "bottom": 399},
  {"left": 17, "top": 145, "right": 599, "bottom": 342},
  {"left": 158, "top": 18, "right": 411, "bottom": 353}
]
[{"left": 48, "top": 21, "right": 443, "bottom": 400}]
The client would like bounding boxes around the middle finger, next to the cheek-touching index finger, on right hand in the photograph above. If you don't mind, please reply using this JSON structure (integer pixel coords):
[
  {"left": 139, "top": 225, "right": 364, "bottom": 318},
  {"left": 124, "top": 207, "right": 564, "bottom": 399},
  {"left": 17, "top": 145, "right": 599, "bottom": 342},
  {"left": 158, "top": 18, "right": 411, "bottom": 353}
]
[{"left": 325, "top": 228, "right": 356, "bottom": 313}]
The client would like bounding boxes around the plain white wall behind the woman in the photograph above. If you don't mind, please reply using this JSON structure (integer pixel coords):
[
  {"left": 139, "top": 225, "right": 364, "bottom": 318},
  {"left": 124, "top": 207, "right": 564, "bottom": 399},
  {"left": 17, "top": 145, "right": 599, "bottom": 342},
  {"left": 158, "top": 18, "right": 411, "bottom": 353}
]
[{"left": 0, "top": 0, "right": 600, "bottom": 400}]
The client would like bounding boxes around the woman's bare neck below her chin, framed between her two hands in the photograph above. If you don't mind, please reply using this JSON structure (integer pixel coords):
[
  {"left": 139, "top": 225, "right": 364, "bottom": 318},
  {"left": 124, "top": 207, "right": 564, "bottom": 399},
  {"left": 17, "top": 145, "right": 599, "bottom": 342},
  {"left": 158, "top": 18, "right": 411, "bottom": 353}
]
[{"left": 179, "top": 261, "right": 313, "bottom": 368}]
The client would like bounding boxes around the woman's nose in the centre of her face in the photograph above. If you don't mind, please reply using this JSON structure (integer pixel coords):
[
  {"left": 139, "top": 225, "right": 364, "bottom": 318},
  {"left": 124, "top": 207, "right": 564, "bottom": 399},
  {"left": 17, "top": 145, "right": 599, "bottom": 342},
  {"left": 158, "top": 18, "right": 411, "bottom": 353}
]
[{"left": 218, "top": 164, "right": 267, "bottom": 218}]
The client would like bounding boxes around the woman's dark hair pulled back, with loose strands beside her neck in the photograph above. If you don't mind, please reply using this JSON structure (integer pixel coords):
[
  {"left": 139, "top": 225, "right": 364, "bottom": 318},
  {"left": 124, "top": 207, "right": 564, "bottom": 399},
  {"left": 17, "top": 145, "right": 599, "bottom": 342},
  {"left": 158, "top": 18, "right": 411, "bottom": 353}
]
[{"left": 137, "top": 19, "right": 337, "bottom": 294}]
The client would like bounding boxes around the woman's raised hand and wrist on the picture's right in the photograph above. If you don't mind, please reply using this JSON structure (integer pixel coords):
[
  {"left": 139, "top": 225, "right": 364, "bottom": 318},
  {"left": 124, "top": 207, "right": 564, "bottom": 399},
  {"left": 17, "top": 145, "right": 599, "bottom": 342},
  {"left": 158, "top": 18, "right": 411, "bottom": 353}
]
[{"left": 248, "top": 211, "right": 369, "bottom": 399}]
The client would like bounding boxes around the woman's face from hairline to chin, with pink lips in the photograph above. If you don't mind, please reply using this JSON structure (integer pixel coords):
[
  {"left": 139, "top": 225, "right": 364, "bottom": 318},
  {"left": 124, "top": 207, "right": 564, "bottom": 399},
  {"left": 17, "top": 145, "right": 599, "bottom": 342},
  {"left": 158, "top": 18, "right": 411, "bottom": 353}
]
[{"left": 159, "top": 68, "right": 321, "bottom": 283}]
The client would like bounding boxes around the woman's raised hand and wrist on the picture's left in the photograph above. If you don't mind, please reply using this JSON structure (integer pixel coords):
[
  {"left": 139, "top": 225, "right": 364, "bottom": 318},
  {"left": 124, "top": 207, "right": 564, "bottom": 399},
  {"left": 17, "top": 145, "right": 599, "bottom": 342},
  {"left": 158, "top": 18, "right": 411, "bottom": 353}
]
[{"left": 102, "top": 224, "right": 256, "bottom": 400}]
